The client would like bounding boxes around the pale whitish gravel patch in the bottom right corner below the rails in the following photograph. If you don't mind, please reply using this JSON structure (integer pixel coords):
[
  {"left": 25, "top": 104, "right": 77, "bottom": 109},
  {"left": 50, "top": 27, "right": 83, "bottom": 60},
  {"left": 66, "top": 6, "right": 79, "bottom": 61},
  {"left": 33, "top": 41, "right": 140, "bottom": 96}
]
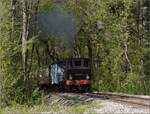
[{"left": 95, "top": 99, "right": 150, "bottom": 114}]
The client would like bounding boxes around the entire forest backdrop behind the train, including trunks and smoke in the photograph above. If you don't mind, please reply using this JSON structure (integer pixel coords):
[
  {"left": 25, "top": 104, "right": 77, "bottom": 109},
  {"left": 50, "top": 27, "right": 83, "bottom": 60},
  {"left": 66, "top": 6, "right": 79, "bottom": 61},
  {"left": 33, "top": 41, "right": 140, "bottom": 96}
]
[{"left": 0, "top": 0, "right": 150, "bottom": 107}]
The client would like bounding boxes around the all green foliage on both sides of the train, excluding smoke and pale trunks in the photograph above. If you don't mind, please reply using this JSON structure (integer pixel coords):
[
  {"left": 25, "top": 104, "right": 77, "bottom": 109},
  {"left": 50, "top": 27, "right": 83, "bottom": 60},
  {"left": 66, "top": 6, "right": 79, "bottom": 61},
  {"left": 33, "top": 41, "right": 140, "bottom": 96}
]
[{"left": 0, "top": 0, "right": 150, "bottom": 109}]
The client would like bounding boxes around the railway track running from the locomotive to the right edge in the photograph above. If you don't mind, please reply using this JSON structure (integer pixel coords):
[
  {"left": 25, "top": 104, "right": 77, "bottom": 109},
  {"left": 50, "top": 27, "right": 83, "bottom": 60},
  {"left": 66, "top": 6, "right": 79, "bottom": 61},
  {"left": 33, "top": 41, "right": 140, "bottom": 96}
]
[{"left": 84, "top": 92, "right": 150, "bottom": 108}]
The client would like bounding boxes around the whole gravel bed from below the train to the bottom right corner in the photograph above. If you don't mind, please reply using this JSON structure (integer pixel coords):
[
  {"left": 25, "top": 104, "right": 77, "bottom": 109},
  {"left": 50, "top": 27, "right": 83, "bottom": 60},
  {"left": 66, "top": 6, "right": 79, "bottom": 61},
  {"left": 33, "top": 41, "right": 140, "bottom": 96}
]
[{"left": 44, "top": 93, "right": 150, "bottom": 114}]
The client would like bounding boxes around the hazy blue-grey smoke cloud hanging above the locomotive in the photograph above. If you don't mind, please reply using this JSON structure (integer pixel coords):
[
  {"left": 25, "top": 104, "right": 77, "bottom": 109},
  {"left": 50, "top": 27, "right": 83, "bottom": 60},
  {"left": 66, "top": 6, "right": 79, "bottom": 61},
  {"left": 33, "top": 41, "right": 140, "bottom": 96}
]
[{"left": 38, "top": 8, "right": 77, "bottom": 46}]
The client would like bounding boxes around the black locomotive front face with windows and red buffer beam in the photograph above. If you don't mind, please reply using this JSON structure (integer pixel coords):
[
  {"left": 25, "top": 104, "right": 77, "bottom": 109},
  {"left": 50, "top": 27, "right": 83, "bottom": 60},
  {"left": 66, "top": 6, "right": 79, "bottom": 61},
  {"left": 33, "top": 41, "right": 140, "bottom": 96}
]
[{"left": 65, "top": 58, "right": 91, "bottom": 91}]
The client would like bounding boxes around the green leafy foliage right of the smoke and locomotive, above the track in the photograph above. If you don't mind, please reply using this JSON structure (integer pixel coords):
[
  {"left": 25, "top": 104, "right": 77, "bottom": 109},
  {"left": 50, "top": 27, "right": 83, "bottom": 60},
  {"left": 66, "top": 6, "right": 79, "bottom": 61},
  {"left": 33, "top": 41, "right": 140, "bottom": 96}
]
[{"left": 68, "top": 0, "right": 149, "bottom": 94}]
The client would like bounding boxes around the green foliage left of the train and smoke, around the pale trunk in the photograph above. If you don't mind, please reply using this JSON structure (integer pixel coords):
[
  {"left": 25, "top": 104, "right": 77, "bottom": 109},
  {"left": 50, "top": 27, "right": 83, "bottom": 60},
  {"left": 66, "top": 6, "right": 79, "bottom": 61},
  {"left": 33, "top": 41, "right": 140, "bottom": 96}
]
[{"left": 0, "top": 0, "right": 72, "bottom": 106}]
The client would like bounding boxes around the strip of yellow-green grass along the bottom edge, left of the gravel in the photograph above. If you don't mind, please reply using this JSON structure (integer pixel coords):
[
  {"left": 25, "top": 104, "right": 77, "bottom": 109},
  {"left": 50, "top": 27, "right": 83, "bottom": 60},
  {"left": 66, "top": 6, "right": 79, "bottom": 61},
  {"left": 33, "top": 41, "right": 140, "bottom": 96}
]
[{"left": 0, "top": 103, "right": 95, "bottom": 114}]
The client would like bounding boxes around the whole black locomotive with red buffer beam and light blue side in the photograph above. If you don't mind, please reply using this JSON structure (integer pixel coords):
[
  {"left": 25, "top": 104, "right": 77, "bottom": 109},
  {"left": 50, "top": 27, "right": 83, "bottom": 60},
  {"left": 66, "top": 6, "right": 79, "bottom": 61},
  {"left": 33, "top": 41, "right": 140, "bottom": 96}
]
[{"left": 49, "top": 58, "right": 91, "bottom": 91}]
